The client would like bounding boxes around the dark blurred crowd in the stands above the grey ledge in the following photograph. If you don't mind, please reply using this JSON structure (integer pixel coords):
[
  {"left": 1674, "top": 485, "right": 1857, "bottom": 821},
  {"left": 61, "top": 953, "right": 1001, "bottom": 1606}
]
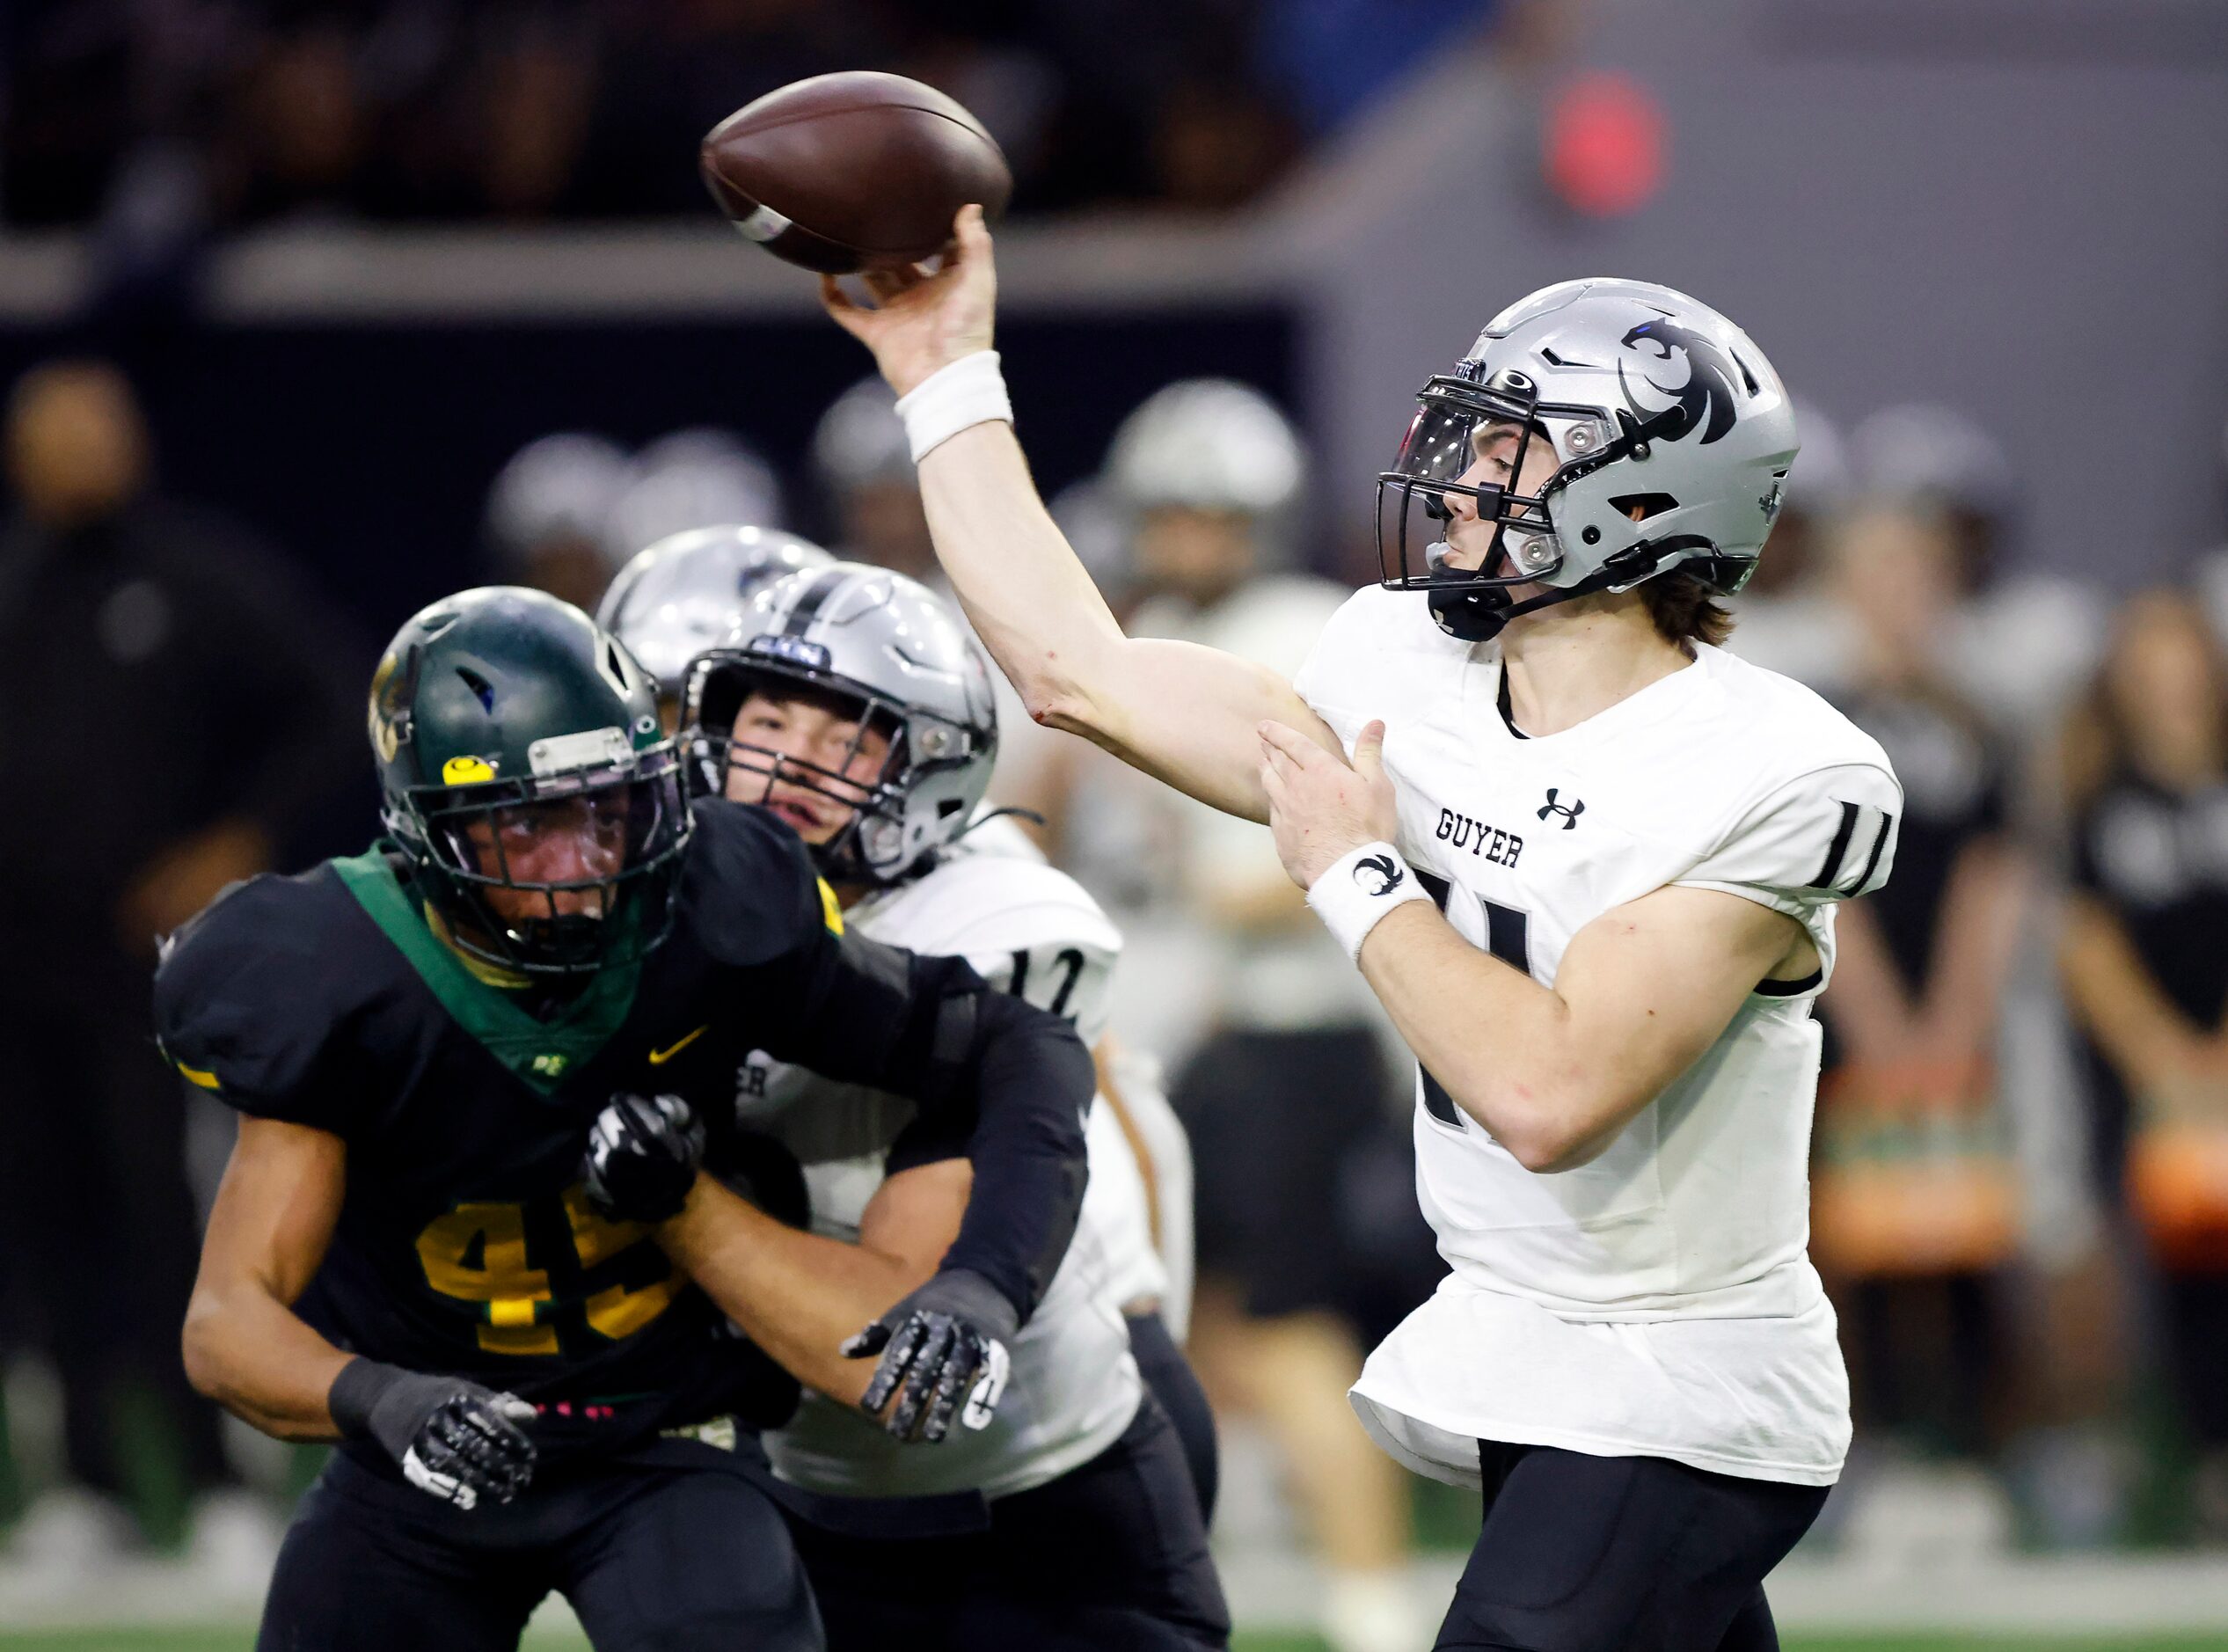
[{"left": 0, "top": 0, "right": 1497, "bottom": 230}]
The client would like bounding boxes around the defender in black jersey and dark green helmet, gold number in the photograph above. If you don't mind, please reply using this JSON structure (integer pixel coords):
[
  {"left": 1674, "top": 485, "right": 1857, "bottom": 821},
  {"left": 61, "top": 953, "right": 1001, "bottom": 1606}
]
[{"left": 156, "top": 588, "right": 1092, "bottom": 1652}]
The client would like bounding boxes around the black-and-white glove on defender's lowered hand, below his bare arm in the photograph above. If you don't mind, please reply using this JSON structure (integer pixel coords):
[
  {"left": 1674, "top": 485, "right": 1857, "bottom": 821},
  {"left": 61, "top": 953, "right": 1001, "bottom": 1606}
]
[{"left": 325, "top": 1360, "right": 535, "bottom": 1509}]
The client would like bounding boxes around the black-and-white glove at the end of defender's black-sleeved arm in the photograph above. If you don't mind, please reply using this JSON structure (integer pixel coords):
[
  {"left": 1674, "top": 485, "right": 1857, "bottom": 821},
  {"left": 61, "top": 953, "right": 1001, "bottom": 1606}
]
[{"left": 842, "top": 1268, "right": 1020, "bottom": 1440}]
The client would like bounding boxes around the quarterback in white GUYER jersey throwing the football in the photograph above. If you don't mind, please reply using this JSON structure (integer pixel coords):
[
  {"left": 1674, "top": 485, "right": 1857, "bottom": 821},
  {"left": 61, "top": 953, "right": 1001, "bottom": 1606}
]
[{"left": 824, "top": 208, "right": 1903, "bottom": 1652}]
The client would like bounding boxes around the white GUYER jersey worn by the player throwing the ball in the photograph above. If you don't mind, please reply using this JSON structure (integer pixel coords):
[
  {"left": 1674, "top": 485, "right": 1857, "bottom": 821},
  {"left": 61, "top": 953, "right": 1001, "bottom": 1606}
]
[{"left": 1297, "top": 588, "right": 1903, "bottom": 1485}]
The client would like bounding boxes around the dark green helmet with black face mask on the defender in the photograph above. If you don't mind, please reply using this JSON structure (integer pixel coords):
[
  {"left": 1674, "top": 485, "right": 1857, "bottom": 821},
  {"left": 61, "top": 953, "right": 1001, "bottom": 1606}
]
[{"left": 369, "top": 587, "right": 689, "bottom": 976}]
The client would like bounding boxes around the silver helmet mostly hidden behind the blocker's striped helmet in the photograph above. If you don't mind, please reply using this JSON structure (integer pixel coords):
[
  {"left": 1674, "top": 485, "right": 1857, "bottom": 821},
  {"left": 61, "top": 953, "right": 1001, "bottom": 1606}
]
[{"left": 595, "top": 524, "right": 836, "bottom": 696}]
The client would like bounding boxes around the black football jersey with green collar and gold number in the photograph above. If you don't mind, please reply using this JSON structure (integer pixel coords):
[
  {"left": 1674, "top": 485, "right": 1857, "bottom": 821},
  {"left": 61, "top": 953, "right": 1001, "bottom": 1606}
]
[{"left": 156, "top": 802, "right": 1081, "bottom": 1444}]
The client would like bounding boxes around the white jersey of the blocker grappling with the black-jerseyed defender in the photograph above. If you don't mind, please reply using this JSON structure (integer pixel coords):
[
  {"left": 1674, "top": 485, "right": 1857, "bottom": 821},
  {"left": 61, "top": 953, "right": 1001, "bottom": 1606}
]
[{"left": 735, "top": 821, "right": 1163, "bottom": 1498}]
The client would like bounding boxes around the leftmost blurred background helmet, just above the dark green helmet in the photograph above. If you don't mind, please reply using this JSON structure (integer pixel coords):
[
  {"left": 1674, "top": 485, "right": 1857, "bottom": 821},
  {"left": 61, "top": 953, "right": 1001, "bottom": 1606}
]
[{"left": 488, "top": 430, "right": 635, "bottom": 609}]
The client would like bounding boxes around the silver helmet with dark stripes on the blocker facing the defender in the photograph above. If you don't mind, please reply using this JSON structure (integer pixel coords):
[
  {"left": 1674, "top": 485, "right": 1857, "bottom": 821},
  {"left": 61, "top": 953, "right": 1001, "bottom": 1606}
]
[{"left": 682, "top": 562, "right": 998, "bottom": 883}]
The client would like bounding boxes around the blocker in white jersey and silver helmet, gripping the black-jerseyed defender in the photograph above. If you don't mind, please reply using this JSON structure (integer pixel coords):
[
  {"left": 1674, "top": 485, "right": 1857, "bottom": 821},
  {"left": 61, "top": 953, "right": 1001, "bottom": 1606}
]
[{"left": 619, "top": 564, "right": 1228, "bottom": 1652}]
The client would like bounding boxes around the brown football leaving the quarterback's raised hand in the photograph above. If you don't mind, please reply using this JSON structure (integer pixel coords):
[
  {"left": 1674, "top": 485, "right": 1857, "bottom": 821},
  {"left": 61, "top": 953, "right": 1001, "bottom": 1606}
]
[{"left": 702, "top": 69, "right": 1014, "bottom": 274}]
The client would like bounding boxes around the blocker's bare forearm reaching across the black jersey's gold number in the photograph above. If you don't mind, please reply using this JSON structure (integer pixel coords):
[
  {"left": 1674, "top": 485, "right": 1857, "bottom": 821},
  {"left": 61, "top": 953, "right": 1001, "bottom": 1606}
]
[{"left": 657, "top": 1175, "right": 933, "bottom": 1405}]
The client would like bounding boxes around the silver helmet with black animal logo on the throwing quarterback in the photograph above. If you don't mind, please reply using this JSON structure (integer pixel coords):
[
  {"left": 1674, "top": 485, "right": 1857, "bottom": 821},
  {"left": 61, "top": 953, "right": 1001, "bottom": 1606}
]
[{"left": 1377, "top": 279, "right": 1796, "bottom": 642}]
